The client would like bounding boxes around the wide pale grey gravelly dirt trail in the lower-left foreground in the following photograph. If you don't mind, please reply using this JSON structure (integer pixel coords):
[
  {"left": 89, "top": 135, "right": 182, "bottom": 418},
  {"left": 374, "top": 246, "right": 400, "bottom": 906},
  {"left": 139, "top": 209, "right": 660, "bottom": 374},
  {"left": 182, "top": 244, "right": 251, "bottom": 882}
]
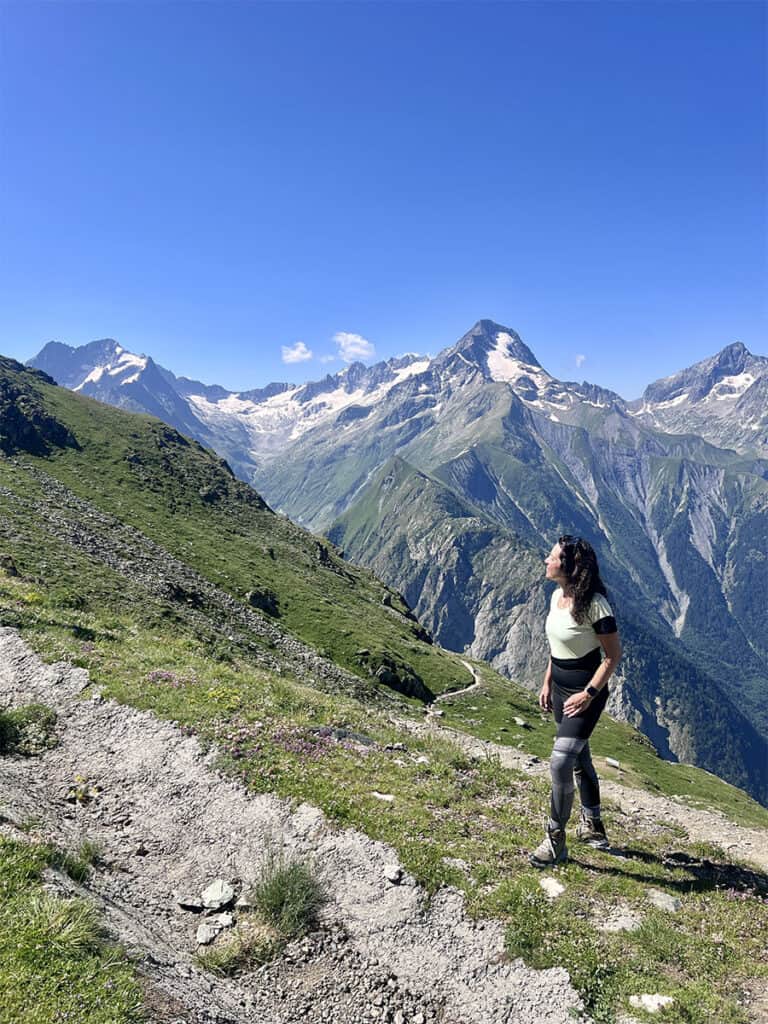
[{"left": 0, "top": 629, "right": 581, "bottom": 1024}]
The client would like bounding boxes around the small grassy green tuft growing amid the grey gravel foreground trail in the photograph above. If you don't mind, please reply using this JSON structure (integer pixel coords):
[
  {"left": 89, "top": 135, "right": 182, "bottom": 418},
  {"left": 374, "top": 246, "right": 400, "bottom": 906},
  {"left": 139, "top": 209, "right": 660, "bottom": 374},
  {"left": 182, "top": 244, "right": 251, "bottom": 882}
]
[{"left": 252, "top": 848, "right": 327, "bottom": 938}]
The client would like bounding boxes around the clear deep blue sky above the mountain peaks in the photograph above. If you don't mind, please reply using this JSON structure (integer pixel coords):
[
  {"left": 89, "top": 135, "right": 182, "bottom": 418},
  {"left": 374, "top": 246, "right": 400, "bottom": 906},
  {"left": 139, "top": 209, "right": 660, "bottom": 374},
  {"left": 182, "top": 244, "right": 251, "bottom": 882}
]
[{"left": 0, "top": 0, "right": 768, "bottom": 397}]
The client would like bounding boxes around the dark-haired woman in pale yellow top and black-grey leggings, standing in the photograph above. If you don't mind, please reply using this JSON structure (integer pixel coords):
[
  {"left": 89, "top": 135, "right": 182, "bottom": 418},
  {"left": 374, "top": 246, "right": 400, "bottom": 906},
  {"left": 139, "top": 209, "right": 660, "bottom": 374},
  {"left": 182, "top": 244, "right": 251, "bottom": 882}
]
[{"left": 530, "top": 535, "right": 622, "bottom": 867}]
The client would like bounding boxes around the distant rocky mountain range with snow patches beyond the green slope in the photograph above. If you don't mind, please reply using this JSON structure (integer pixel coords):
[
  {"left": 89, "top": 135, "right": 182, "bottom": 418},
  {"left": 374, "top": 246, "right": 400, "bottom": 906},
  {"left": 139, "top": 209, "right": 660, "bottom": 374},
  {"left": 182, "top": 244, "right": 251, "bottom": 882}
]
[{"left": 31, "top": 321, "right": 768, "bottom": 802}]
